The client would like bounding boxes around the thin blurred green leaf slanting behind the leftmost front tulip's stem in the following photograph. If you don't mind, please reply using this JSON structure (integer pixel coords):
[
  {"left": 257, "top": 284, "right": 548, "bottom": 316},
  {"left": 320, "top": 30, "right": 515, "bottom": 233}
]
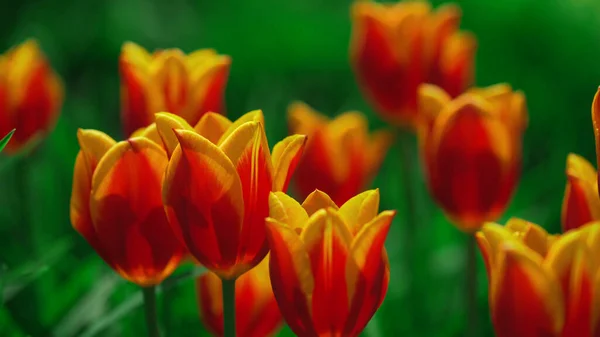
[{"left": 80, "top": 267, "right": 206, "bottom": 337}]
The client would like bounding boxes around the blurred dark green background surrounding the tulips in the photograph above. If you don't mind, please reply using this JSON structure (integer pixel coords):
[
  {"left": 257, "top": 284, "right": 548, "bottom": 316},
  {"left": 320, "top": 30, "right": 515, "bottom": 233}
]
[{"left": 0, "top": 0, "right": 600, "bottom": 337}]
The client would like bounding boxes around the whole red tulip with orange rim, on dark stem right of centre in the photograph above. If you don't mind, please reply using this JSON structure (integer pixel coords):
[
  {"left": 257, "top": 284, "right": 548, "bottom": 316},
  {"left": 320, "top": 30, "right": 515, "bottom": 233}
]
[{"left": 419, "top": 84, "right": 527, "bottom": 232}]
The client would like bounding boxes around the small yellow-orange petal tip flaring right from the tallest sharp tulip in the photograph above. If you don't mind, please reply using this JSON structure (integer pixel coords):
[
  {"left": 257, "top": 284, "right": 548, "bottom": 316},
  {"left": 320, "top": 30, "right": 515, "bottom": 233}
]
[{"left": 272, "top": 135, "right": 307, "bottom": 192}]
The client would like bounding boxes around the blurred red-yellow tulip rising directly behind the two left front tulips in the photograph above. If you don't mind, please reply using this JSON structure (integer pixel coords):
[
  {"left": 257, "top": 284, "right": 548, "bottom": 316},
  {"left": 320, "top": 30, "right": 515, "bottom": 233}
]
[{"left": 119, "top": 42, "right": 231, "bottom": 135}]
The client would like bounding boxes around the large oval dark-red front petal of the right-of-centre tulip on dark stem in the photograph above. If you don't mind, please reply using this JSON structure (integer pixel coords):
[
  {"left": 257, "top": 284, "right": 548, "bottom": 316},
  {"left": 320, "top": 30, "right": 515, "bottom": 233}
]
[{"left": 428, "top": 94, "right": 515, "bottom": 231}]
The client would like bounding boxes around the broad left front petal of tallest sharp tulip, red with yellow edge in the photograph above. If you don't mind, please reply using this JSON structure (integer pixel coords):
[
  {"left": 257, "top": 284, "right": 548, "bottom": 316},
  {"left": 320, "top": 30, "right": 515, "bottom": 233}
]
[{"left": 163, "top": 130, "right": 244, "bottom": 277}]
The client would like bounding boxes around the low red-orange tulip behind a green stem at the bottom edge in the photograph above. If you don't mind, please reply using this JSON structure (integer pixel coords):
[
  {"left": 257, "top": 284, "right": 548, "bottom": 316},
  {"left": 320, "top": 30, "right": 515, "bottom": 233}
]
[{"left": 196, "top": 255, "right": 283, "bottom": 337}]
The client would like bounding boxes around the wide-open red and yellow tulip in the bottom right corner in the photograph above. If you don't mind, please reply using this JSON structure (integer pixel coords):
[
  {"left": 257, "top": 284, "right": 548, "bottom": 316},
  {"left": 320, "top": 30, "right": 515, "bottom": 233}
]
[{"left": 477, "top": 220, "right": 600, "bottom": 337}]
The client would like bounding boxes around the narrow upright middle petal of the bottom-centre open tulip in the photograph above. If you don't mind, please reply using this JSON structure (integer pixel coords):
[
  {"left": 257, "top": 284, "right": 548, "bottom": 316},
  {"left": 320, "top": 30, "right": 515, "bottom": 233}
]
[{"left": 301, "top": 208, "right": 352, "bottom": 335}]
